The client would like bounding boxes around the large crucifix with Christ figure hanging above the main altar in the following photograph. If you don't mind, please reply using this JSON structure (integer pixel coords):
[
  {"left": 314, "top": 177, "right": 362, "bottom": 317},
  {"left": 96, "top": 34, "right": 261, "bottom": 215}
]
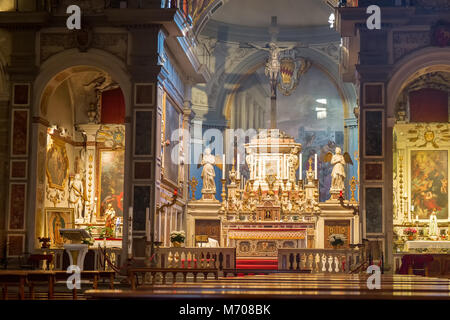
[{"left": 249, "top": 16, "right": 296, "bottom": 129}]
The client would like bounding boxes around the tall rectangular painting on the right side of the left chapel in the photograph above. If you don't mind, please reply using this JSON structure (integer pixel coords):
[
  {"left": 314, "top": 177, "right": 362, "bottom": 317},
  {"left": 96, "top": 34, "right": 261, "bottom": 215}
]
[{"left": 97, "top": 148, "right": 125, "bottom": 218}]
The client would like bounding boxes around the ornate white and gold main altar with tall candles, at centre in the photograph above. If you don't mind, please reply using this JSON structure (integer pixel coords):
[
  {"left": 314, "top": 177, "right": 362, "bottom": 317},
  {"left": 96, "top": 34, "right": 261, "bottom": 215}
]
[{"left": 187, "top": 129, "right": 360, "bottom": 258}]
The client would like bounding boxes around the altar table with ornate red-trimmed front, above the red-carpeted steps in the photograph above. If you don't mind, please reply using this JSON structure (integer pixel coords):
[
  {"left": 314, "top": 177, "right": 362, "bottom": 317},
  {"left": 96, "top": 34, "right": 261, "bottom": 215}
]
[{"left": 222, "top": 222, "right": 314, "bottom": 258}]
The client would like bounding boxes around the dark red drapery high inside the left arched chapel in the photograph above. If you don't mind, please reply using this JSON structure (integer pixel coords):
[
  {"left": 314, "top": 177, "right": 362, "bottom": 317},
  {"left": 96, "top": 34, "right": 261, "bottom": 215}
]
[{"left": 101, "top": 88, "right": 125, "bottom": 123}]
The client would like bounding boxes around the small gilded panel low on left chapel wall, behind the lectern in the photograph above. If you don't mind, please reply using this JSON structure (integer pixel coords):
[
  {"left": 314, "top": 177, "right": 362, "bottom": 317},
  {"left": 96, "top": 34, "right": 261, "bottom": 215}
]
[{"left": 45, "top": 208, "right": 75, "bottom": 248}]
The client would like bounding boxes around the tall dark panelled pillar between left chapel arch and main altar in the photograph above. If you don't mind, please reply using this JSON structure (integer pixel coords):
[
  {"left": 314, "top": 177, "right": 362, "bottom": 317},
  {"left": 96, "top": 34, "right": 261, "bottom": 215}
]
[{"left": 124, "top": 25, "right": 166, "bottom": 263}]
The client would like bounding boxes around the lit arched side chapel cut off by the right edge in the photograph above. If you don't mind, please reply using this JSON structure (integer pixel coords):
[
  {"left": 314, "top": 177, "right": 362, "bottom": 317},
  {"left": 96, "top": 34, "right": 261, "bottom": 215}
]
[{"left": 388, "top": 62, "right": 450, "bottom": 258}]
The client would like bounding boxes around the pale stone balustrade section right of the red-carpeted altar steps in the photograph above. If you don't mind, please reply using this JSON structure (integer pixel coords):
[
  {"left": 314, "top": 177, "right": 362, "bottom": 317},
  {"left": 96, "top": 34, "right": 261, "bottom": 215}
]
[{"left": 278, "top": 249, "right": 364, "bottom": 273}]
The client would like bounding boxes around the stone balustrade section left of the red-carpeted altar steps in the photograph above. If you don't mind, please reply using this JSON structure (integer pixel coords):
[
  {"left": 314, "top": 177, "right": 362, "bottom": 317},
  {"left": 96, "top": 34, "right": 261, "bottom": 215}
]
[{"left": 153, "top": 247, "right": 236, "bottom": 270}]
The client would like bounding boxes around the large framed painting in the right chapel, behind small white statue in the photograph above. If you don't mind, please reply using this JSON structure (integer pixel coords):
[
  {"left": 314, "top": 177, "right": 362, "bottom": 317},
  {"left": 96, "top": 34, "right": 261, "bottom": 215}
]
[{"left": 409, "top": 150, "right": 449, "bottom": 220}]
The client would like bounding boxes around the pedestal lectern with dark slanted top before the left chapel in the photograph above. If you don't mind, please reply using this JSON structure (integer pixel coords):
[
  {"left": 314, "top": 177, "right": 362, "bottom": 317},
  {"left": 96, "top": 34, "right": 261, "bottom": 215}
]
[{"left": 59, "top": 229, "right": 91, "bottom": 271}]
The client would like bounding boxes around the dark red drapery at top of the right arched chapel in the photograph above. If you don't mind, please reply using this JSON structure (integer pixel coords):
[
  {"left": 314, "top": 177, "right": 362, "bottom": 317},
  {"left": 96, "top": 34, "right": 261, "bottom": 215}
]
[{"left": 409, "top": 88, "right": 448, "bottom": 122}]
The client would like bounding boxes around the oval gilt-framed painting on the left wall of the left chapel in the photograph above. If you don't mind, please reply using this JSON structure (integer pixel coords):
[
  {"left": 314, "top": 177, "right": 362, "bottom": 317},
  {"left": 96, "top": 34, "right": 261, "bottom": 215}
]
[{"left": 46, "top": 137, "right": 69, "bottom": 190}]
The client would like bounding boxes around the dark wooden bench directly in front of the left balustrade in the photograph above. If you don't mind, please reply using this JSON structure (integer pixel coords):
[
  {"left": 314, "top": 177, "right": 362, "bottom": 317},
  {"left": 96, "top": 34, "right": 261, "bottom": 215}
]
[{"left": 128, "top": 268, "right": 219, "bottom": 289}]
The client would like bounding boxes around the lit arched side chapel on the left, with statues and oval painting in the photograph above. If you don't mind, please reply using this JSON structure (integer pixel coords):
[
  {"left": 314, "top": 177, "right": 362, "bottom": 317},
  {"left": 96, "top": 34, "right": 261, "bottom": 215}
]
[{"left": 31, "top": 65, "right": 126, "bottom": 255}]
